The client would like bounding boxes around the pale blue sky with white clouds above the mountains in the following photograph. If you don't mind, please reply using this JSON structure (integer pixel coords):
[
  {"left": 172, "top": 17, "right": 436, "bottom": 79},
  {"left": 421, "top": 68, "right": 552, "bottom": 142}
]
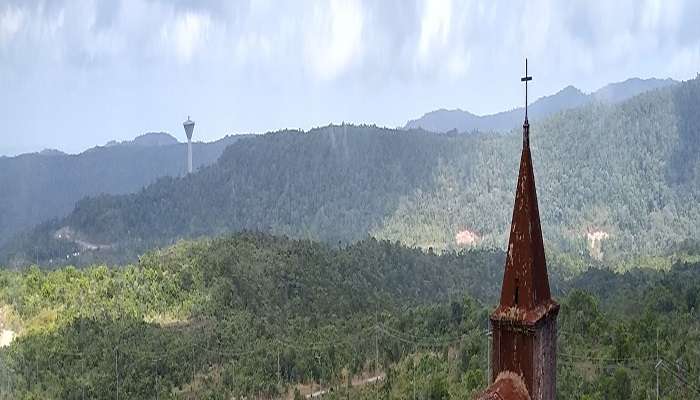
[{"left": 0, "top": 0, "right": 700, "bottom": 155}]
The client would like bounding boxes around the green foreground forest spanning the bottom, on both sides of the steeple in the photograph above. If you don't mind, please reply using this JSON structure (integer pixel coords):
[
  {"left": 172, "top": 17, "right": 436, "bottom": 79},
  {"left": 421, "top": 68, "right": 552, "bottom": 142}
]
[{"left": 0, "top": 232, "right": 700, "bottom": 399}]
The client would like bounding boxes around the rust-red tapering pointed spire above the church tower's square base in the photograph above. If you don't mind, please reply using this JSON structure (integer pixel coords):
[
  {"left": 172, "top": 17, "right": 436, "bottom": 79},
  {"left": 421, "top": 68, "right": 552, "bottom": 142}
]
[{"left": 495, "top": 58, "right": 555, "bottom": 322}]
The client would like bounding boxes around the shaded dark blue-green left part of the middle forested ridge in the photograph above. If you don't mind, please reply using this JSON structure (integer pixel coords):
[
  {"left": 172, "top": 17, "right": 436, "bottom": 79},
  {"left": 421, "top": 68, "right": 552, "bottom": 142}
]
[{"left": 13, "top": 126, "right": 456, "bottom": 258}]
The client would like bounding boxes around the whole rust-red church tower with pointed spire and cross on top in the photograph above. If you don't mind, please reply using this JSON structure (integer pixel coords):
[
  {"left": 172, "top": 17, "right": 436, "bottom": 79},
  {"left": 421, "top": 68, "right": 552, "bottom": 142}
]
[{"left": 481, "top": 60, "right": 559, "bottom": 400}]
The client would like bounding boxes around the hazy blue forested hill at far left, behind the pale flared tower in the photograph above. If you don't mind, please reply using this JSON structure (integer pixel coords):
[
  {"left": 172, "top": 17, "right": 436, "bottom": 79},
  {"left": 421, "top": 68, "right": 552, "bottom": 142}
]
[{"left": 0, "top": 133, "right": 246, "bottom": 245}]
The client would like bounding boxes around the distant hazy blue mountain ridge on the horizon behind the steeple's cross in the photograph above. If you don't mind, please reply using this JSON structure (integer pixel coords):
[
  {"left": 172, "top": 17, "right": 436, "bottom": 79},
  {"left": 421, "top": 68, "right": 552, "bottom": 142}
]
[{"left": 405, "top": 78, "right": 677, "bottom": 132}]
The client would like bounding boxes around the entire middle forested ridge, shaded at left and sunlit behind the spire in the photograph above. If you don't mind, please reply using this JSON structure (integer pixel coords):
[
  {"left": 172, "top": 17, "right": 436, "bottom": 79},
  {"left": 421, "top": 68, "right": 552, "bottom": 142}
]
[{"left": 3, "top": 79, "right": 700, "bottom": 264}]
